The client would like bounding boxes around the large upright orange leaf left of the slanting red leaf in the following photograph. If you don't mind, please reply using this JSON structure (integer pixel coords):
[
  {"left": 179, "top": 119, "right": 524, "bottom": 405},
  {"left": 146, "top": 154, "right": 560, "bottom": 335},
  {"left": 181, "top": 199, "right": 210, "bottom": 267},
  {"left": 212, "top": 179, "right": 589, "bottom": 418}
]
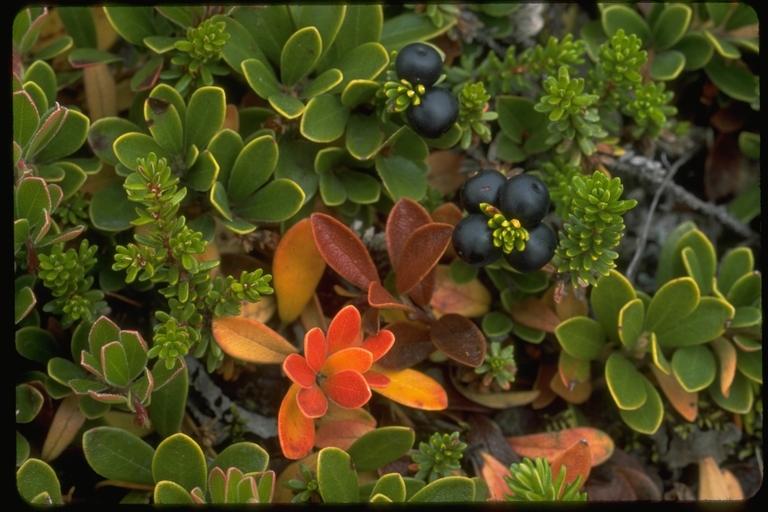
[{"left": 272, "top": 219, "right": 325, "bottom": 323}]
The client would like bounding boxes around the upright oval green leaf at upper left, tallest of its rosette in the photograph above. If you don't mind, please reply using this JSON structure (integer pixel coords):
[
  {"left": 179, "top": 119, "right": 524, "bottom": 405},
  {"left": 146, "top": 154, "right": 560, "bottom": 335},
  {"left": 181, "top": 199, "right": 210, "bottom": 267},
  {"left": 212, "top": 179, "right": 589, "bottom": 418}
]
[{"left": 185, "top": 87, "right": 227, "bottom": 150}]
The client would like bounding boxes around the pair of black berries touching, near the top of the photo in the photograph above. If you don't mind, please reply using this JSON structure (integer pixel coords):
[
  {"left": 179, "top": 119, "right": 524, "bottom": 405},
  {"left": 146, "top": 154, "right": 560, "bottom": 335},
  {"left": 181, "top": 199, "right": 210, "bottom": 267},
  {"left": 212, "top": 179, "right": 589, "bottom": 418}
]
[{"left": 395, "top": 43, "right": 459, "bottom": 139}]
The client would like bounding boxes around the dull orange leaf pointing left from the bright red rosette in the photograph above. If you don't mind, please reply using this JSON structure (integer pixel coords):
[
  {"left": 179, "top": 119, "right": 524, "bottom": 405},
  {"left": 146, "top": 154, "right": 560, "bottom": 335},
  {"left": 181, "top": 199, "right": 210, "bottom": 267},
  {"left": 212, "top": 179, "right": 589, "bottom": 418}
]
[{"left": 212, "top": 316, "right": 297, "bottom": 363}]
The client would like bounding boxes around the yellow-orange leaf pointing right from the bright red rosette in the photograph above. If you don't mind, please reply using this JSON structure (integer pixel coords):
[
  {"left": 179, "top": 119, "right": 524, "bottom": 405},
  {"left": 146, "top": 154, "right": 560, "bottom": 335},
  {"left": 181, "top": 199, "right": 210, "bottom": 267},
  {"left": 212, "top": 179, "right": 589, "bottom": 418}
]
[{"left": 372, "top": 365, "right": 448, "bottom": 411}]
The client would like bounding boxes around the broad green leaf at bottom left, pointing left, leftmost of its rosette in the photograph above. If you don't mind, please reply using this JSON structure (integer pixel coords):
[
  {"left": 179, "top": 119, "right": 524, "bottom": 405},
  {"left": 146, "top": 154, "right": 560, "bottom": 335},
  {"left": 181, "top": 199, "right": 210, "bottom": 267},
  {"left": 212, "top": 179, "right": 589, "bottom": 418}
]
[{"left": 83, "top": 427, "right": 155, "bottom": 485}]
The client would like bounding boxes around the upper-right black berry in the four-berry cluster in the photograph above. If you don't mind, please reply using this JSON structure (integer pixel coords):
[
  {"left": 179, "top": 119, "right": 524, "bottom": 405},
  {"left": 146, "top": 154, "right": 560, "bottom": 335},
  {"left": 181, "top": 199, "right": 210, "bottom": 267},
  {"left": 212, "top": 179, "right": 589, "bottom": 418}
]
[{"left": 499, "top": 174, "right": 549, "bottom": 228}]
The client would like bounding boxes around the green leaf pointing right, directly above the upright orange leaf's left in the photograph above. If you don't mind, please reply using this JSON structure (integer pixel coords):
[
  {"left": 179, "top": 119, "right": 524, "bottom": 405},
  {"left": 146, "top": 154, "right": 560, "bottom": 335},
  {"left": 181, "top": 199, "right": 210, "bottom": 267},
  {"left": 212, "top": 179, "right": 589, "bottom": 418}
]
[{"left": 233, "top": 179, "right": 304, "bottom": 223}]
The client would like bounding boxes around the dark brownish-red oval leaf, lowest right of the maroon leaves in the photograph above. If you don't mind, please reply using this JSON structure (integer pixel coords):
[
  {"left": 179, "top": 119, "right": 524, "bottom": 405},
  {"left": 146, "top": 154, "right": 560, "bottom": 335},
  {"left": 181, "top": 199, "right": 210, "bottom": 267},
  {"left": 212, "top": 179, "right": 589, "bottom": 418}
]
[{"left": 430, "top": 313, "right": 486, "bottom": 368}]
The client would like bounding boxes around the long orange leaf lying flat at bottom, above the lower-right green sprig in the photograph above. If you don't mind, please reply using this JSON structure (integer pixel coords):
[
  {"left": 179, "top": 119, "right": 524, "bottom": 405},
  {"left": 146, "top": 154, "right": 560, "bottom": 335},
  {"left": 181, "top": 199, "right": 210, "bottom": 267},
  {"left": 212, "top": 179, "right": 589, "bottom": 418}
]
[{"left": 507, "top": 427, "right": 613, "bottom": 467}]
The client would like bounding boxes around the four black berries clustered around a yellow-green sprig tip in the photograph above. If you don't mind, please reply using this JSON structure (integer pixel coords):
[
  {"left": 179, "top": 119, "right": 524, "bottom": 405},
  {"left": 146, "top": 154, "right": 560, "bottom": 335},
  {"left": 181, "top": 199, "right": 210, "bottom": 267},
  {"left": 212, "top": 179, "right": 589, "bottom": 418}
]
[{"left": 452, "top": 169, "right": 557, "bottom": 273}]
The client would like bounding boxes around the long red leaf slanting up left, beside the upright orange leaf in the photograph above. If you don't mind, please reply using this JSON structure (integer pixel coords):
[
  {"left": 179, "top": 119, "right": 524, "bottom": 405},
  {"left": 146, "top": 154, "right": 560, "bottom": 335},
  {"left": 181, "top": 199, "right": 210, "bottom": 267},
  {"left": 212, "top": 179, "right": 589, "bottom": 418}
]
[{"left": 311, "top": 213, "right": 380, "bottom": 290}]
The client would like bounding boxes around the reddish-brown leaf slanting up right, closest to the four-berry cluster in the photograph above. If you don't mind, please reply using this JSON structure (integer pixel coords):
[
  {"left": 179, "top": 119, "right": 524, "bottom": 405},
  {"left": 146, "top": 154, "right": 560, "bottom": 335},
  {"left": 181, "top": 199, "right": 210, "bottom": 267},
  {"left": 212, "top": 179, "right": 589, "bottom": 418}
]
[{"left": 395, "top": 222, "right": 453, "bottom": 295}]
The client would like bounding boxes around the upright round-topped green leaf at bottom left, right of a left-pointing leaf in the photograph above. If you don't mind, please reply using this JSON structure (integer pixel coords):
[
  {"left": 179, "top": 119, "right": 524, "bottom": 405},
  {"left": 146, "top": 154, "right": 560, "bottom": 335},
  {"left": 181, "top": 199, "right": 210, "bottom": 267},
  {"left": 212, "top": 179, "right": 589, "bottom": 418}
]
[{"left": 152, "top": 434, "right": 208, "bottom": 492}]
